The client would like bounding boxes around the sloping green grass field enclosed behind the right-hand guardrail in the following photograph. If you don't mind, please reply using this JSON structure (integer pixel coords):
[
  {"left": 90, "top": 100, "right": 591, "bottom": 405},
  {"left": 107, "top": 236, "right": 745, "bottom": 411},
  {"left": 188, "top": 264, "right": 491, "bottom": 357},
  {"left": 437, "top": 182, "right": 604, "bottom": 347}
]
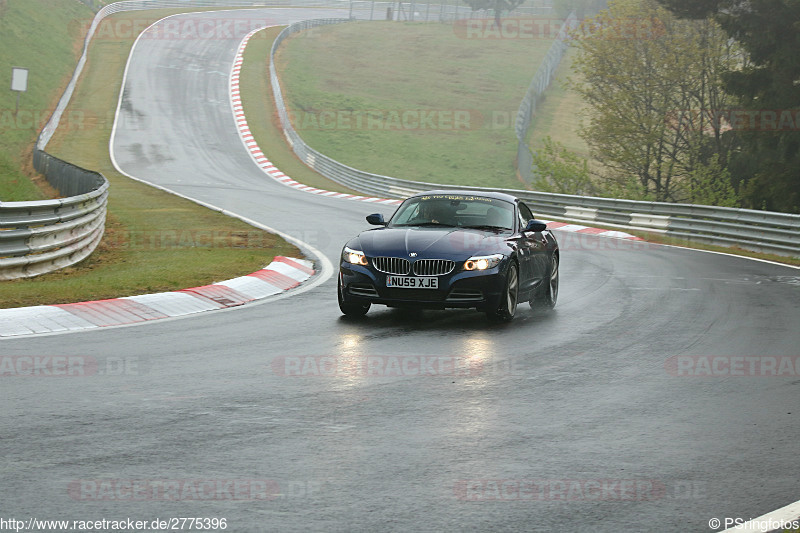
[{"left": 276, "top": 22, "right": 552, "bottom": 188}]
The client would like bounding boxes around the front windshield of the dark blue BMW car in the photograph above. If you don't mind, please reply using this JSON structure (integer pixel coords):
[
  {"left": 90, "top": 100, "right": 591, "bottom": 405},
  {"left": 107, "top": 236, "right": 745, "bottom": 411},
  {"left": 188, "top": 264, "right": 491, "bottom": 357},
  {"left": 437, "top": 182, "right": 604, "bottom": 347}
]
[{"left": 389, "top": 194, "right": 514, "bottom": 231}]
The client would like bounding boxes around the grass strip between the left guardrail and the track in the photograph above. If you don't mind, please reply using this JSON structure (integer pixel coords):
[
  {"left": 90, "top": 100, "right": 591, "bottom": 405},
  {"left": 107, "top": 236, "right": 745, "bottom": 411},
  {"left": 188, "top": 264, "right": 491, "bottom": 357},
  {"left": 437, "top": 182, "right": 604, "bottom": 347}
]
[{"left": 0, "top": 11, "right": 300, "bottom": 307}]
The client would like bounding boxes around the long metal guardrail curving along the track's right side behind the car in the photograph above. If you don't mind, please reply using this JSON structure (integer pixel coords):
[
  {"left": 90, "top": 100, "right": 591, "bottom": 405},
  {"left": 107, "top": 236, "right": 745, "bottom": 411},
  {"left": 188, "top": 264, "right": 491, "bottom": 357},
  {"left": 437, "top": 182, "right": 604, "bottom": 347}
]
[{"left": 270, "top": 19, "right": 800, "bottom": 256}]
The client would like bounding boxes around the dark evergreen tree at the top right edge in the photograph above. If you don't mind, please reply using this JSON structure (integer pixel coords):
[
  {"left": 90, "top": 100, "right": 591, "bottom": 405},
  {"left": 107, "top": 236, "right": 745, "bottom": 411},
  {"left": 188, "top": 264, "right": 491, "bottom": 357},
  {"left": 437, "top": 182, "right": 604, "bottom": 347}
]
[{"left": 659, "top": 0, "right": 800, "bottom": 213}]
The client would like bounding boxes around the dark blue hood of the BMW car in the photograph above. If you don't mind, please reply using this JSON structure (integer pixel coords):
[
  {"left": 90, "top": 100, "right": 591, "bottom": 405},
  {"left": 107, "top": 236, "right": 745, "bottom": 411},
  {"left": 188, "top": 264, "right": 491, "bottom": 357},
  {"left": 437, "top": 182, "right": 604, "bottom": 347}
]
[{"left": 353, "top": 227, "right": 509, "bottom": 260}]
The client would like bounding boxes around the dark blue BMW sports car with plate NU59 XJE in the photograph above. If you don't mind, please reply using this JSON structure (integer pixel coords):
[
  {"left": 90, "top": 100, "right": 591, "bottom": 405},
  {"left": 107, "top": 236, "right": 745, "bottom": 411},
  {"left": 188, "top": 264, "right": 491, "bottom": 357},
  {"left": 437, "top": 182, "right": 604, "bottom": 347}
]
[{"left": 337, "top": 190, "right": 559, "bottom": 321}]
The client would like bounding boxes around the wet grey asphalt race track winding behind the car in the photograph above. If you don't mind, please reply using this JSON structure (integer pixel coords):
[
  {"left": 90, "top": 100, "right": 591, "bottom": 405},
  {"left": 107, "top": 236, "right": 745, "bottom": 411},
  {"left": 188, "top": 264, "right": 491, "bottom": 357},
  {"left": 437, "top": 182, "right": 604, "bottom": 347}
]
[{"left": 0, "top": 10, "right": 800, "bottom": 531}]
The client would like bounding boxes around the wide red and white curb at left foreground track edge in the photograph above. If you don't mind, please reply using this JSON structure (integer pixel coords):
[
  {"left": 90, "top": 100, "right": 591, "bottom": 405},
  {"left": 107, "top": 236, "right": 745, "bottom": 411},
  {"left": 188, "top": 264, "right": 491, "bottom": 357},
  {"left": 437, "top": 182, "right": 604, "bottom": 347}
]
[{"left": 0, "top": 256, "right": 315, "bottom": 337}]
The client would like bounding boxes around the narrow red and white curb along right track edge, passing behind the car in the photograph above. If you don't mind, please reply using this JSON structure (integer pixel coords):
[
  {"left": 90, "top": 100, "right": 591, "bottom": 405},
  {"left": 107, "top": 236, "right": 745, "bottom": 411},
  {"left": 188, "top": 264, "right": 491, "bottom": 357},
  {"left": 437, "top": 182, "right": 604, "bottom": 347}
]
[{"left": 230, "top": 28, "right": 642, "bottom": 240}]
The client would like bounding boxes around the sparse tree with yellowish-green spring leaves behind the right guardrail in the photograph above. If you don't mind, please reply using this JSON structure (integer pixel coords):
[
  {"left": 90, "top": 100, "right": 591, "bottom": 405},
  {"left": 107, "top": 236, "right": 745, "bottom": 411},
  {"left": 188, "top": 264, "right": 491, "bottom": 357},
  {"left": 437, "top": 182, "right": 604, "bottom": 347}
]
[{"left": 572, "top": 0, "right": 739, "bottom": 202}]
